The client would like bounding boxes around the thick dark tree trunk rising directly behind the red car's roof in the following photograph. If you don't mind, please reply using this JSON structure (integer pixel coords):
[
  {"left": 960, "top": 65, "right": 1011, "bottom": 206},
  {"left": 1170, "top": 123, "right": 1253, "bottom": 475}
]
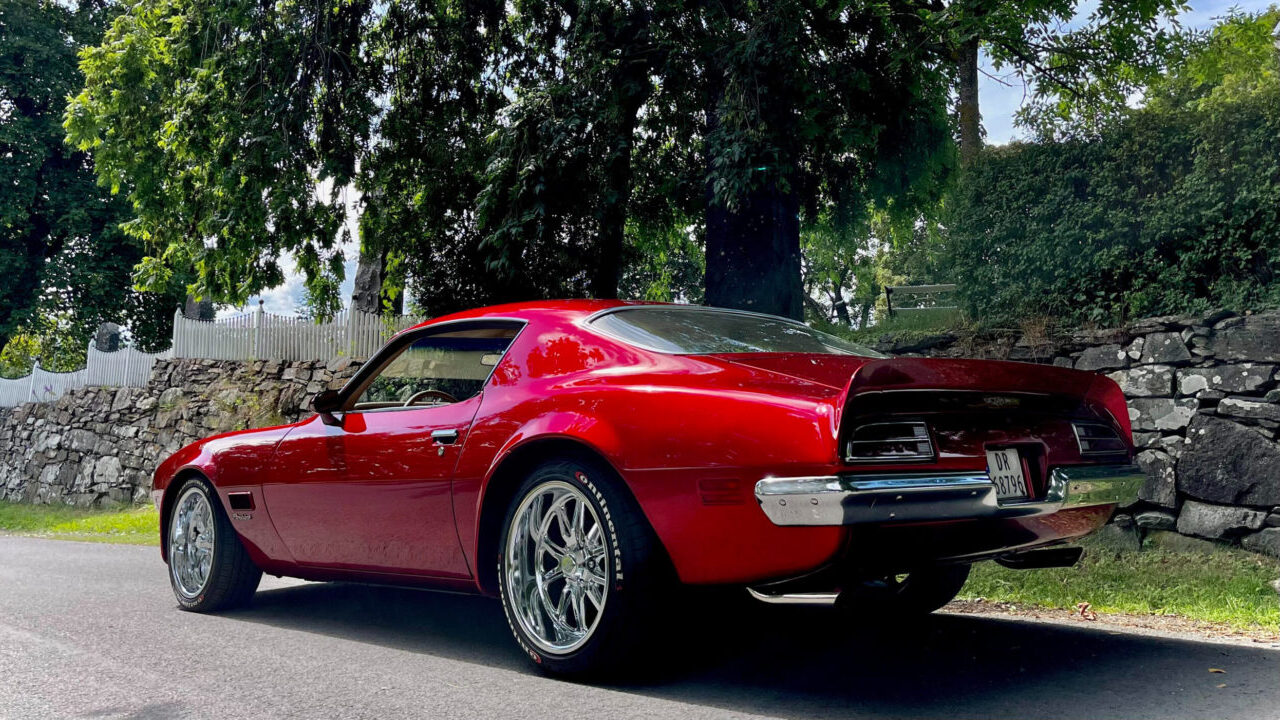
[{"left": 705, "top": 178, "right": 804, "bottom": 320}]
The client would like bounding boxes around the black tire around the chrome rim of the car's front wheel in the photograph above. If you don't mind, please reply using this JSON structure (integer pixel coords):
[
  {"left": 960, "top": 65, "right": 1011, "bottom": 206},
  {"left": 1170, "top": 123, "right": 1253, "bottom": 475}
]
[{"left": 165, "top": 477, "right": 262, "bottom": 612}]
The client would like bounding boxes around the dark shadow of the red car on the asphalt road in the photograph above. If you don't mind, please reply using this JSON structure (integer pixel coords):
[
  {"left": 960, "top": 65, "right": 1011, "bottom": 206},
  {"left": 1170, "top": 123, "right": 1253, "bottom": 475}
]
[{"left": 228, "top": 584, "right": 1280, "bottom": 719}]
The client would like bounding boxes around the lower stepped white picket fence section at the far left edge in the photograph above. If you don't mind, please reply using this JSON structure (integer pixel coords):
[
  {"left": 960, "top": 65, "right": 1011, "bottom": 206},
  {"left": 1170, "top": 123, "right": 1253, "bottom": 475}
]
[{"left": 0, "top": 343, "right": 170, "bottom": 407}]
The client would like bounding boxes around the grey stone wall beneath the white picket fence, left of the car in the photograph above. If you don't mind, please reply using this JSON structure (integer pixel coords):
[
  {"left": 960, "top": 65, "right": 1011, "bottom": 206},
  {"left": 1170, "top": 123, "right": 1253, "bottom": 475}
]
[{"left": 0, "top": 359, "right": 358, "bottom": 506}]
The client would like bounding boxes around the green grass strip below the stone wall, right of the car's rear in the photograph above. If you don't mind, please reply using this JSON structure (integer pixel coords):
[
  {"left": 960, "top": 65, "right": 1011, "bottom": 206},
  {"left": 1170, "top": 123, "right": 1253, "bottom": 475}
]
[{"left": 961, "top": 538, "right": 1280, "bottom": 632}]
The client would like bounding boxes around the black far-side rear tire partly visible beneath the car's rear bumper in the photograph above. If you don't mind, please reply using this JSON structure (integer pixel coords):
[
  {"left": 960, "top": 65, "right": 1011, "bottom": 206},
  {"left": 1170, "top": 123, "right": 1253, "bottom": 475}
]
[{"left": 836, "top": 564, "right": 969, "bottom": 618}]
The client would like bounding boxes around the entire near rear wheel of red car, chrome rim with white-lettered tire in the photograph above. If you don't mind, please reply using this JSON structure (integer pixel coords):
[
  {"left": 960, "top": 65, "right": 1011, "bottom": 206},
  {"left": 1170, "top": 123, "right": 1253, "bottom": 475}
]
[{"left": 498, "top": 460, "right": 667, "bottom": 675}]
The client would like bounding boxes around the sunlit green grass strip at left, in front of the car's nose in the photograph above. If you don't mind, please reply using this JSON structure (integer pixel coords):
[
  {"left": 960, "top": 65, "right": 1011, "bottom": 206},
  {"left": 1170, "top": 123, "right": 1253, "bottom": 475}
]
[{"left": 0, "top": 502, "right": 160, "bottom": 544}]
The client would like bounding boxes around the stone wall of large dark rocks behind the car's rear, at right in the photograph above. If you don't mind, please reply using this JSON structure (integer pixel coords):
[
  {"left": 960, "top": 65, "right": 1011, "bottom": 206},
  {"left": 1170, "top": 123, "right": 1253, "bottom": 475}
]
[{"left": 877, "top": 311, "right": 1280, "bottom": 556}]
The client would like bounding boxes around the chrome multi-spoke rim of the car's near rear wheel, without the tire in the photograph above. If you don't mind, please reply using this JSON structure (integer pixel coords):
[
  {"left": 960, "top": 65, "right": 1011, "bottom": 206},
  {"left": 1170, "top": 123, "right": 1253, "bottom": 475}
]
[{"left": 503, "top": 480, "right": 609, "bottom": 655}]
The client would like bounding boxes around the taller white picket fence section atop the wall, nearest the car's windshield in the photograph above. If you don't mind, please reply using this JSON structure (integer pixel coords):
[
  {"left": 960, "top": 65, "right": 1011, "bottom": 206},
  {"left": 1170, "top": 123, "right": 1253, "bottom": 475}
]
[{"left": 173, "top": 305, "right": 422, "bottom": 360}]
